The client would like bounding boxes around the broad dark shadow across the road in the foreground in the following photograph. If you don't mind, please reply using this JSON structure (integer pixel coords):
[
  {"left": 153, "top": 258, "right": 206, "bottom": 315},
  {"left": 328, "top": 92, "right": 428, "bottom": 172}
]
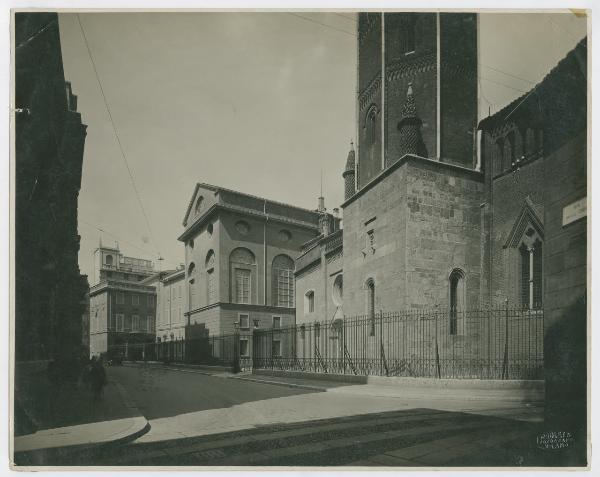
[{"left": 22, "top": 408, "right": 577, "bottom": 467}]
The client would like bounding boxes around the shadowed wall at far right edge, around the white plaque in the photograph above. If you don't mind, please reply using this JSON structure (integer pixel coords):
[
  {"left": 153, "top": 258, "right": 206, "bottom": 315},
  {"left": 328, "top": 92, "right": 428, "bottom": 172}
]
[{"left": 543, "top": 130, "right": 588, "bottom": 448}]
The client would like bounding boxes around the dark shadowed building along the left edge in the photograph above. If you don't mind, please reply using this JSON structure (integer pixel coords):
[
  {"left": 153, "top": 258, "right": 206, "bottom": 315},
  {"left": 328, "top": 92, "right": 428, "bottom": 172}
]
[{"left": 15, "top": 13, "right": 88, "bottom": 363}]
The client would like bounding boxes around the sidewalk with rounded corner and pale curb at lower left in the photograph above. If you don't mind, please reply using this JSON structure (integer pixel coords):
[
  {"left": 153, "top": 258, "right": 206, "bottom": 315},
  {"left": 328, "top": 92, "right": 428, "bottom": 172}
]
[{"left": 13, "top": 368, "right": 150, "bottom": 466}]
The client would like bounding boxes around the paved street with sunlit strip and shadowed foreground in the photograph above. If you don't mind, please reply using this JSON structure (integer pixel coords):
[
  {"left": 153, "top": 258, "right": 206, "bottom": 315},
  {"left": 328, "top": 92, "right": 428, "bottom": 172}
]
[{"left": 47, "top": 367, "right": 564, "bottom": 467}]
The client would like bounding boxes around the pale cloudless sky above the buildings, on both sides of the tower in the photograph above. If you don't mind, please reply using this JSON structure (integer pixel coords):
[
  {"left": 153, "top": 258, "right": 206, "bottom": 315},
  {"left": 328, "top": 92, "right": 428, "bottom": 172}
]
[{"left": 59, "top": 12, "right": 587, "bottom": 276}]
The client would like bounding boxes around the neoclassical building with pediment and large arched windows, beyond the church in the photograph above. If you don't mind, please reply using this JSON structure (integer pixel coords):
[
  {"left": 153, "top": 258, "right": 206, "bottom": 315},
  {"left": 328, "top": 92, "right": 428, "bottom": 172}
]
[{"left": 179, "top": 183, "right": 339, "bottom": 346}]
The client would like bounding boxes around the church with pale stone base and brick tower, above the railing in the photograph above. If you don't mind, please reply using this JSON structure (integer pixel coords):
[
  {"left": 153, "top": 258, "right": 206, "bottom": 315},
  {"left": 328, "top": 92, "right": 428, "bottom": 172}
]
[{"left": 296, "top": 13, "right": 587, "bottom": 328}]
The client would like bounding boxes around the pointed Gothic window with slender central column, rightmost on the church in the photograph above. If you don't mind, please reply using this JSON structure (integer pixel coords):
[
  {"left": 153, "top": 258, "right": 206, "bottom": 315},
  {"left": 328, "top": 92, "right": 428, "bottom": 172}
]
[{"left": 519, "top": 237, "right": 543, "bottom": 310}]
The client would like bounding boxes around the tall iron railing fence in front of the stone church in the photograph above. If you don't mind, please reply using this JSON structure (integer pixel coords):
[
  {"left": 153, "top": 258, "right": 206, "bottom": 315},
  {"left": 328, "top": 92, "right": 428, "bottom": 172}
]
[{"left": 252, "top": 308, "right": 543, "bottom": 379}]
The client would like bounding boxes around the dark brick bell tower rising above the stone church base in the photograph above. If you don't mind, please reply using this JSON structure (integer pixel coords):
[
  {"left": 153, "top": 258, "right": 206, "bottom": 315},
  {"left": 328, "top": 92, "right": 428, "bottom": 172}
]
[{"left": 356, "top": 13, "right": 478, "bottom": 189}]
